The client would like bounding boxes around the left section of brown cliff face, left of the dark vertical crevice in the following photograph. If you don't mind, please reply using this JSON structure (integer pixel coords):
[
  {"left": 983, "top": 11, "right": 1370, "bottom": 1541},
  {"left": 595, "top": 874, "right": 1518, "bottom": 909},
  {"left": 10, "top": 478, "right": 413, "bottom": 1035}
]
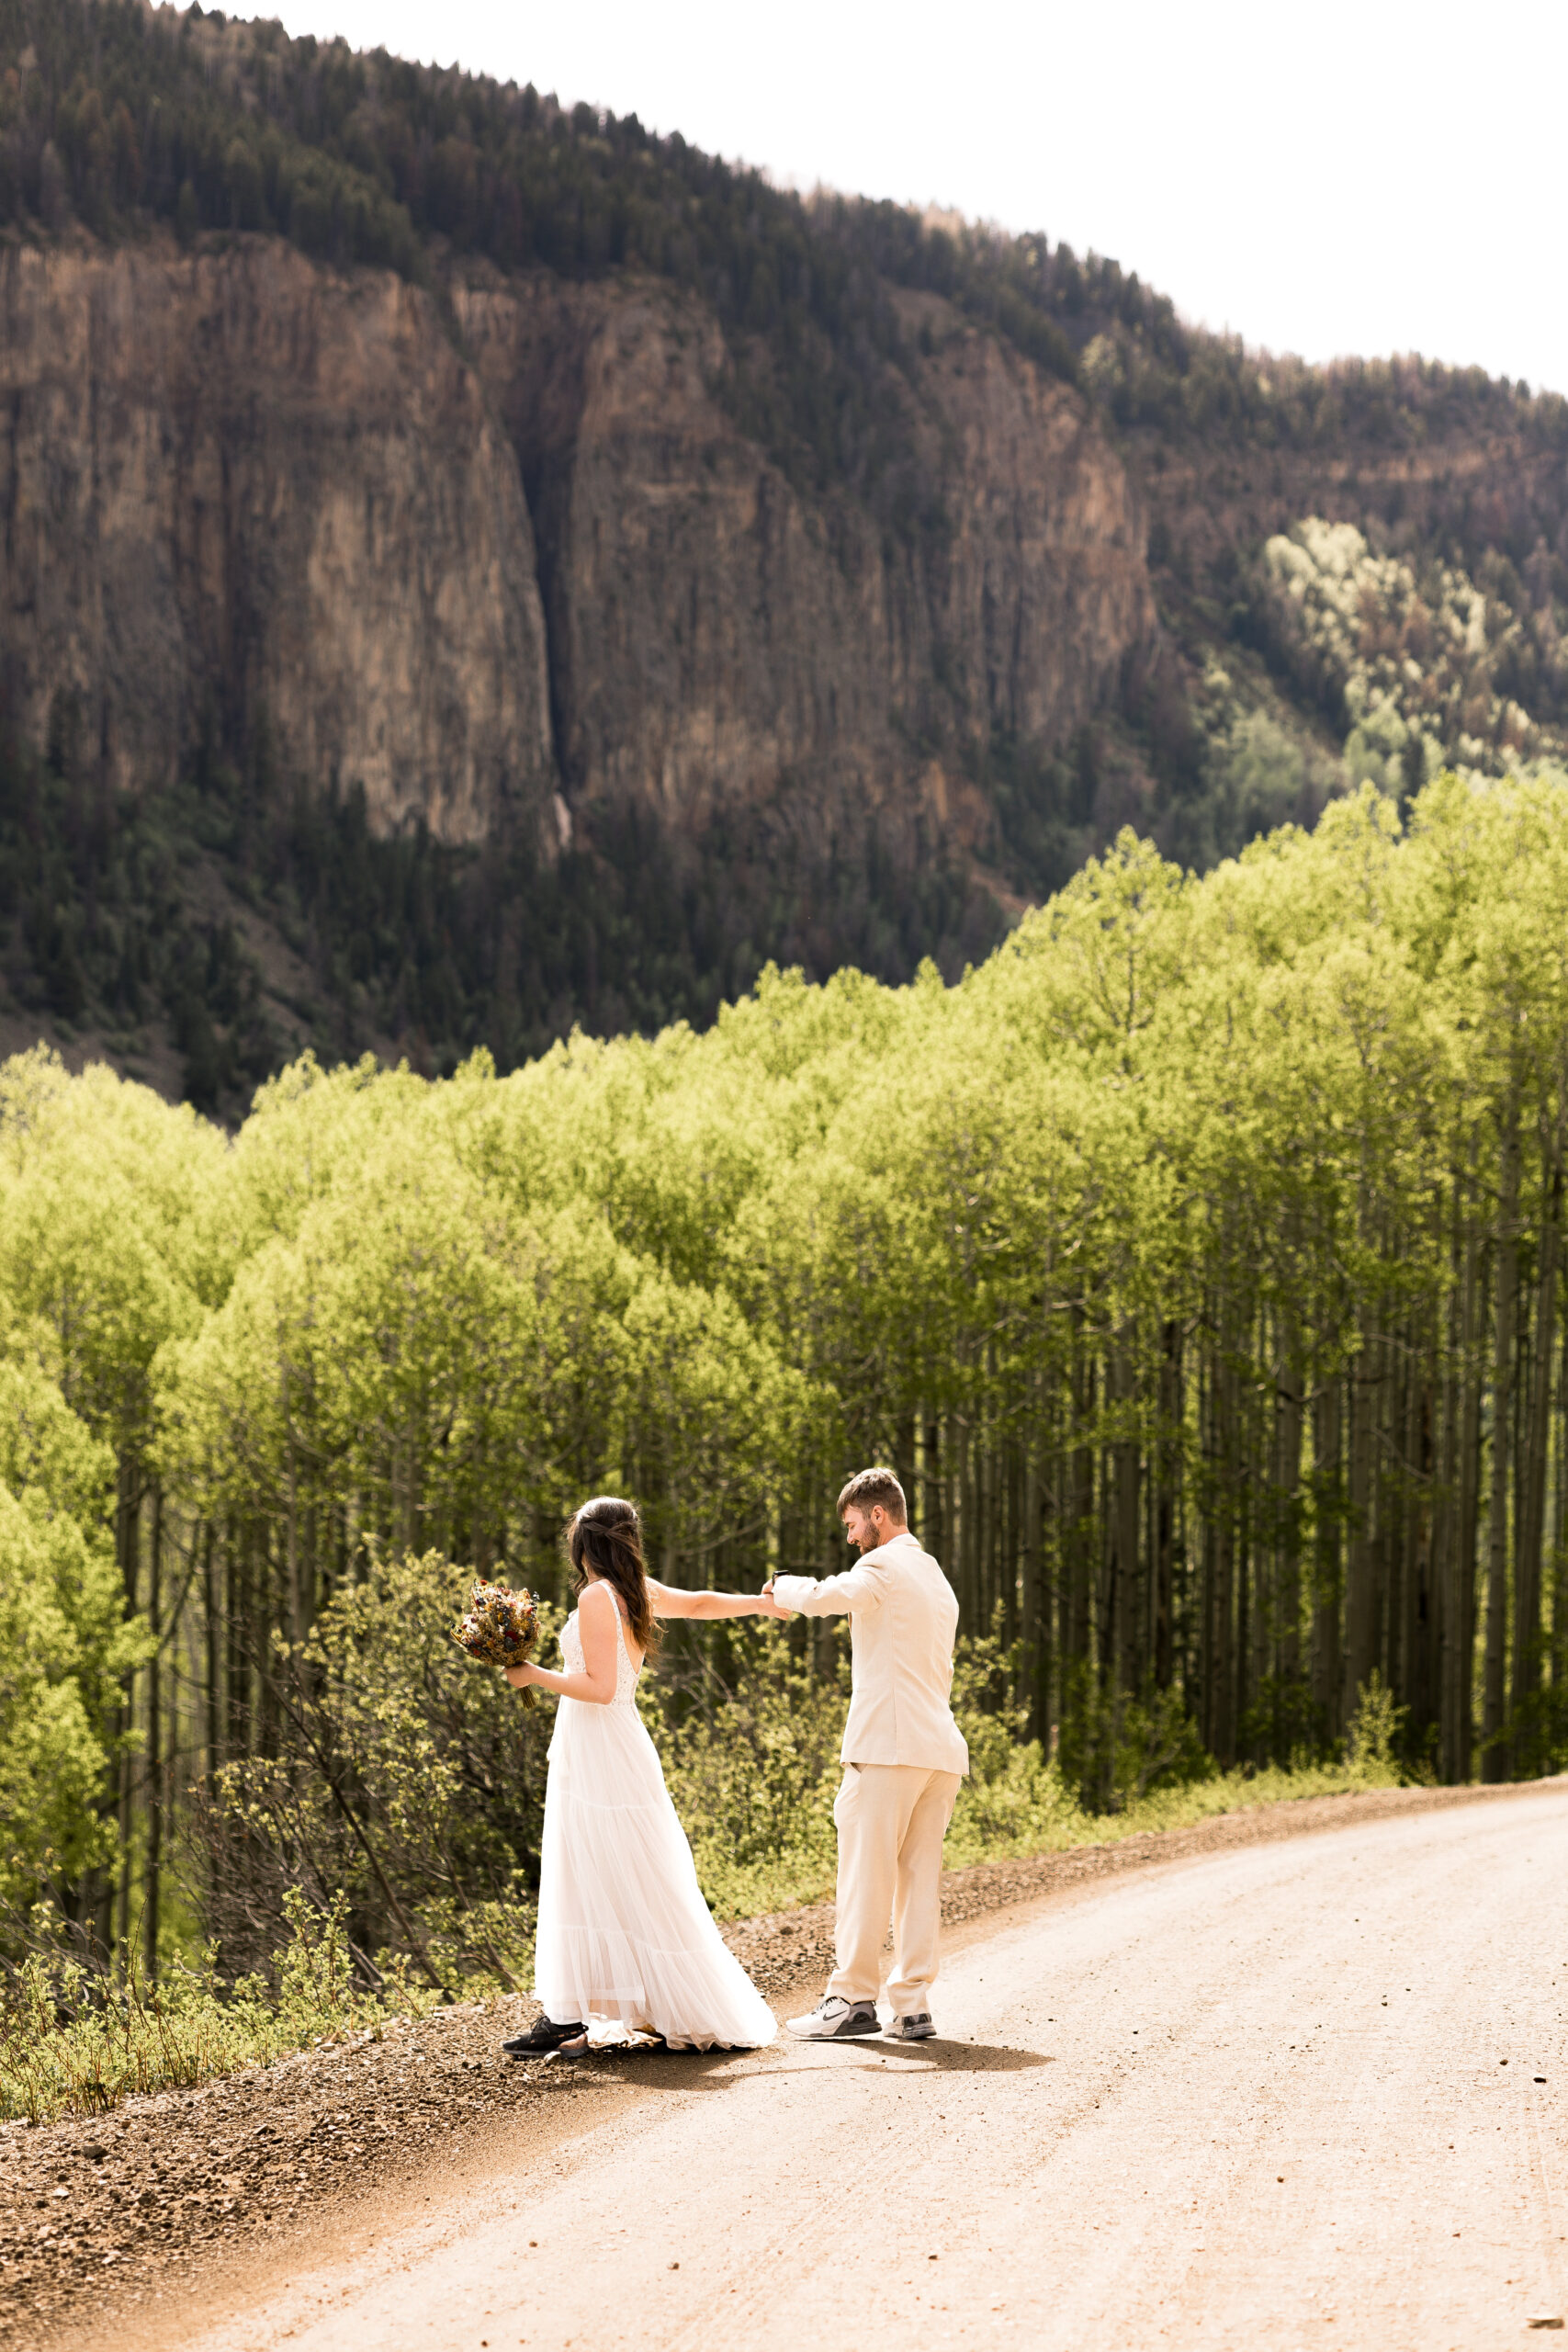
[{"left": 0, "top": 238, "right": 552, "bottom": 840}]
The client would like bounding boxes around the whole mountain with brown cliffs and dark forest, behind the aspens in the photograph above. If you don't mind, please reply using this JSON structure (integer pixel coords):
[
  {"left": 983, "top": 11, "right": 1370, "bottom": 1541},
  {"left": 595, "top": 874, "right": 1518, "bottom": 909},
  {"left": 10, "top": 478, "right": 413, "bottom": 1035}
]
[{"left": 0, "top": 0, "right": 1568, "bottom": 1108}]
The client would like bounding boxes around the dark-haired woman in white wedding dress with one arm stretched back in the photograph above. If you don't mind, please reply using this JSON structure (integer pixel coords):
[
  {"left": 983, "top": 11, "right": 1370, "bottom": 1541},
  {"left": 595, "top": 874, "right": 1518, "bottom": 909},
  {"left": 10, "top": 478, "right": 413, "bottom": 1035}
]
[{"left": 501, "top": 1494, "right": 783, "bottom": 2058}]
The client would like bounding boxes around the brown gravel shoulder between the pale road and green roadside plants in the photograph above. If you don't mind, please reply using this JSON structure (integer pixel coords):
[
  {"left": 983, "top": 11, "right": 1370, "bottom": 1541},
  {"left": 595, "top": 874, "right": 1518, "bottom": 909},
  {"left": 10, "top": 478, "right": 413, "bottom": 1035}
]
[{"left": 0, "top": 1788, "right": 1518, "bottom": 2345}]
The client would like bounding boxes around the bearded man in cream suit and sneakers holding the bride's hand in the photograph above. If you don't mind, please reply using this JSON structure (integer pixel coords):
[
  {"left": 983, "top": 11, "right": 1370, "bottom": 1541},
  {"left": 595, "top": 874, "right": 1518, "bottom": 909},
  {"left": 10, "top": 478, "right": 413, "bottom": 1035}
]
[{"left": 769, "top": 1470, "right": 968, "bottom": 2041}]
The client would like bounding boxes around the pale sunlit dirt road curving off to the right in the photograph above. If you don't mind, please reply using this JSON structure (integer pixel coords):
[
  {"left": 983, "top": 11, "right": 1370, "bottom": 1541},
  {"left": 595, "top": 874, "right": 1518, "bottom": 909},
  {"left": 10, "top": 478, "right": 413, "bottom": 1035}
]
[{"left": 95, "top": 1788, "right": 1568, "bottom": 2352}]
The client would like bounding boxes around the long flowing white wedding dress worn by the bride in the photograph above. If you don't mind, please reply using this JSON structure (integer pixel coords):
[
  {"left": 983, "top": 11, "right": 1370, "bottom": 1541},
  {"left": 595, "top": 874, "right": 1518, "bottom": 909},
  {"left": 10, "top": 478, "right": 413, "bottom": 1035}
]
[{"left": 534, "top": 1609, "right": 778, "bottom": 2051}]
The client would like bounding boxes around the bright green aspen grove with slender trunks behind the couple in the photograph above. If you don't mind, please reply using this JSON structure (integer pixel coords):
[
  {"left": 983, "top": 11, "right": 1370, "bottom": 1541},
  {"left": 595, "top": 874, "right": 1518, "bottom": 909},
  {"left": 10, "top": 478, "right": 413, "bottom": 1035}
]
[{"left": 0, "top": 774, "right": 1568, "bottom": 2041}]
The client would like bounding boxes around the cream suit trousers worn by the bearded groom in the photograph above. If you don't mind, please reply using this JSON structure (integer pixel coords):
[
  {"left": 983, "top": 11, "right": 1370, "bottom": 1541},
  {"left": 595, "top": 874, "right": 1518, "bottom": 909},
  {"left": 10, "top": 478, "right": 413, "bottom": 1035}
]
[{"left": 828, "top": 1764, "right": 959, "bottom": 2018}]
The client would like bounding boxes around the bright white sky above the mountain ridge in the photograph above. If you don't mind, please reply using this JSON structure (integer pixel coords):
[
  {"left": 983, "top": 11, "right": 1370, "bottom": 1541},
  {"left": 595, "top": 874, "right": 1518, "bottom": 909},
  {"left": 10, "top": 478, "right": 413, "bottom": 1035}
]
[{"left": 266, "top": 0, "right": 1568, "bottom": 393}]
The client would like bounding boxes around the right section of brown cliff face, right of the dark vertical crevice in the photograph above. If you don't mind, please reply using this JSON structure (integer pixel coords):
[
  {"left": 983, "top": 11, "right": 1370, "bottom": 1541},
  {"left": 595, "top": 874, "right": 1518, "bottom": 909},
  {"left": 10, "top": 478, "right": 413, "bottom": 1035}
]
[{"left": 456, "top": 277, "right": 1155, "bottom": 855}]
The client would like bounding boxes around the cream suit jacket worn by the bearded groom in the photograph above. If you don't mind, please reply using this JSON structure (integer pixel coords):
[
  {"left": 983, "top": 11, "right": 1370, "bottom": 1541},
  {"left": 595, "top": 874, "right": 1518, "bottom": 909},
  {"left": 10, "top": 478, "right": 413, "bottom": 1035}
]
[{"left": 773, "top": 1529, "right": 968, "bottom": 1771}]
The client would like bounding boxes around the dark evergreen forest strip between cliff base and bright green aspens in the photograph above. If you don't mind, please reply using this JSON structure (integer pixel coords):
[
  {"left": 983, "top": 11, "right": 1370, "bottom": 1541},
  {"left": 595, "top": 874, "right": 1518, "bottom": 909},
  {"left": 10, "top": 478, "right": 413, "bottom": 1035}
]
[{"left": 0, "top": 710, "right": 1006, "bottom": 1122}]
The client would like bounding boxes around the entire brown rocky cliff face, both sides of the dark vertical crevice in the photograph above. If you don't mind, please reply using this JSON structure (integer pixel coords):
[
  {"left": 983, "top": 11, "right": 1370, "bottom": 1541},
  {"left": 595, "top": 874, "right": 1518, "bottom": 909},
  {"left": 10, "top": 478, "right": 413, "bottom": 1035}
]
[{"left": 0, "top": 240, "right": 1155, "bottom": 840}]
